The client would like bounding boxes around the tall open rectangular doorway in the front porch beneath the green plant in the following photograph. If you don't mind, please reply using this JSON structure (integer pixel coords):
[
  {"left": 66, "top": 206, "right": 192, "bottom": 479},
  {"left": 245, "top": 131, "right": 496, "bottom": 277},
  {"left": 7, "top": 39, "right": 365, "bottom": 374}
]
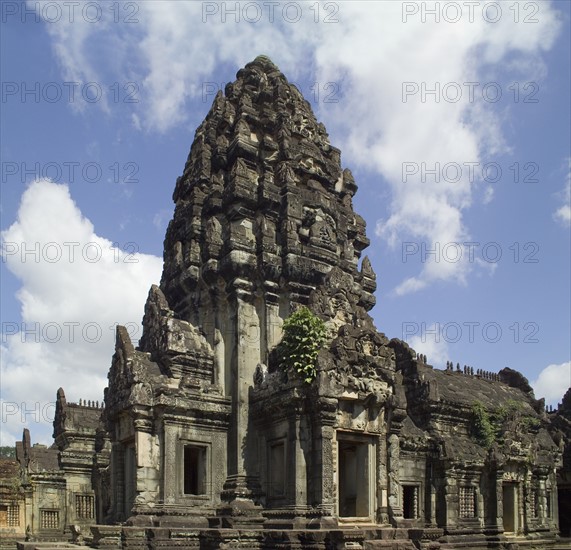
[{"left": 338, "top": 439, "right": 371, "bottom": 518}]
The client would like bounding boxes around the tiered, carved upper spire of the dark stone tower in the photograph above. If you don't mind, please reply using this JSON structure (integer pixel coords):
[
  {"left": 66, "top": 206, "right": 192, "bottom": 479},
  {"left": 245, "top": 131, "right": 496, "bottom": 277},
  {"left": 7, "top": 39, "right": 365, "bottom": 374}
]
[{"left": 161, "top": 56, "right": 376, "bottom": 332}]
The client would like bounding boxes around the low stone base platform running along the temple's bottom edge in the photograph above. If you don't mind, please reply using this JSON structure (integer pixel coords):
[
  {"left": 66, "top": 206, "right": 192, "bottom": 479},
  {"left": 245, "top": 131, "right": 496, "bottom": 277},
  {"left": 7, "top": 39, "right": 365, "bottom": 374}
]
[{"left": 18, "top": 525, "right": 571, "bottom": 550}]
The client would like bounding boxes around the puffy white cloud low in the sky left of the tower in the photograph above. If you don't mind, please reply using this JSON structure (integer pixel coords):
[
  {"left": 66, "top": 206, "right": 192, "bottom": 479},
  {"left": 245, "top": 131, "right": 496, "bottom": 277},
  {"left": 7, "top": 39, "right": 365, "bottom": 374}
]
[{"left": 1, "top": 180, "right": 162, "bottom": 444}]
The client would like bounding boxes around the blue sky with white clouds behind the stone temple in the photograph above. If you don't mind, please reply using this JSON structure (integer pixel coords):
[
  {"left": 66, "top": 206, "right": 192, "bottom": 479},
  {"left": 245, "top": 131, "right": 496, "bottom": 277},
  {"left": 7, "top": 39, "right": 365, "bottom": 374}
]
[{"left": 0, "top": 0, "right": 571, "bottom": 444}]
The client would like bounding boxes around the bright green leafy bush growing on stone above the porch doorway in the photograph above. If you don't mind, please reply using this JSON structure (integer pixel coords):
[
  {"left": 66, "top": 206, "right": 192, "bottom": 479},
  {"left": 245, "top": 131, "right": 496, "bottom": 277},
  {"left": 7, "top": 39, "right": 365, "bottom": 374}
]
[{"left": 277, "top": 306, "right": 326, "bottom": 384}]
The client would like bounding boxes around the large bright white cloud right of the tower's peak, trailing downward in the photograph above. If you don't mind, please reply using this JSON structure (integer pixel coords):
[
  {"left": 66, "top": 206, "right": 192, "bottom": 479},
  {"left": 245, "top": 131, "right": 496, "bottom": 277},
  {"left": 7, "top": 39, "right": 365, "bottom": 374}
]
[{"left": 318, "top": 2, "right": 558, "bottom": 294}]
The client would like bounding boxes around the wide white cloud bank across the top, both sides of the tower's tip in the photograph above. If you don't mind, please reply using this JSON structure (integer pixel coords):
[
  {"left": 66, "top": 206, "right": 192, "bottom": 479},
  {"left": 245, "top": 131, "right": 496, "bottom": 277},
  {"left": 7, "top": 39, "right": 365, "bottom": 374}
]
[{"left": 25, "top": 0, "right": 568, "bottom": 294}]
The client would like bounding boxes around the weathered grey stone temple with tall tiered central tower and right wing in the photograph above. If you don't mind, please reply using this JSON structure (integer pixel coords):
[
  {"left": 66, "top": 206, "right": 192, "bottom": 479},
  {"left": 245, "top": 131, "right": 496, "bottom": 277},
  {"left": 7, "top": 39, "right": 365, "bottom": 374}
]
[{"left": 5, "top": 57, "right": 571, "bottom": 550}]
